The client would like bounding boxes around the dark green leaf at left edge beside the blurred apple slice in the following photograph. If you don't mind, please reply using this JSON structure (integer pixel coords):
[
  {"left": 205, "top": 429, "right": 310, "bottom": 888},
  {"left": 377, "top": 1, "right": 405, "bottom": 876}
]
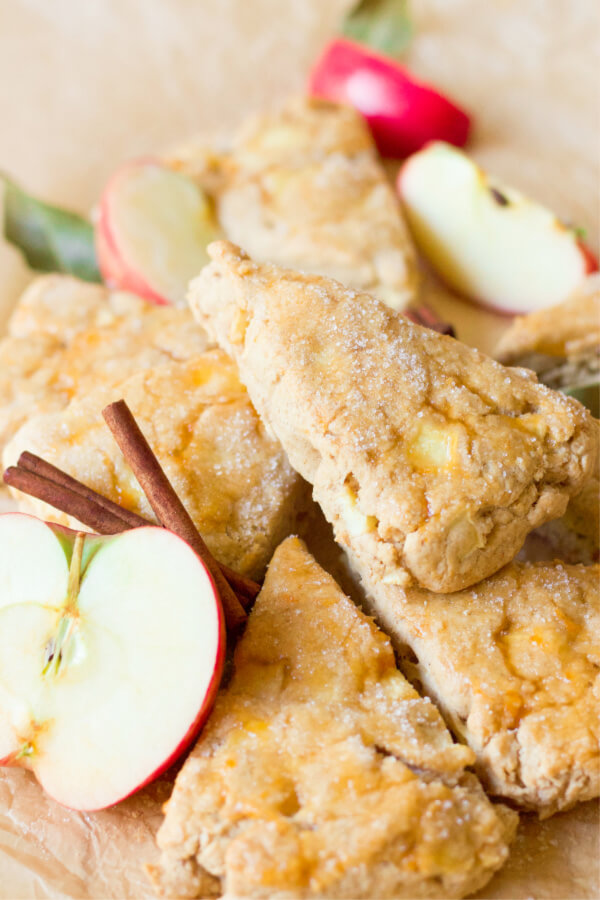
[{"left": 0, "top": 173, "right": 102, "bottom": 282}]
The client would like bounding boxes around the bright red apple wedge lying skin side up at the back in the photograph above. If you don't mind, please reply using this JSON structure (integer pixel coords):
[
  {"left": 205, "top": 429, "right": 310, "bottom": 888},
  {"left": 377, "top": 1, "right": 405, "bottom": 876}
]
[{"left": 308, "top": 38, "right": 471, "bottom": 157}]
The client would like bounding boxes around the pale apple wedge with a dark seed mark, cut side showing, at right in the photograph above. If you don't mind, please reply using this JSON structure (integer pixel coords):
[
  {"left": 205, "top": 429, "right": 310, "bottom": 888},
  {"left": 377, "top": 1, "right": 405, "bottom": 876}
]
[{"left": 398, "top": 142, "right": 598, "bottom": 313}]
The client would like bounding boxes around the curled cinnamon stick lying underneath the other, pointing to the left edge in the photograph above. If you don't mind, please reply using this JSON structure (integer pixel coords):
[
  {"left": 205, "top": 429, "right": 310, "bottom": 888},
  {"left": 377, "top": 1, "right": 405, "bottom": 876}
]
[{"left": 4, "top": 451, "right": 260, "bottom": 609}]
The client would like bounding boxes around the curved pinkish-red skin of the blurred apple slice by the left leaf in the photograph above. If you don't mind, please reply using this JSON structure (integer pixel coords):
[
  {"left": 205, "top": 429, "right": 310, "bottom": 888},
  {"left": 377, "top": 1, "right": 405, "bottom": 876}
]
[{"left": 95, "top": 158, "right": 170, "bottom": 306}]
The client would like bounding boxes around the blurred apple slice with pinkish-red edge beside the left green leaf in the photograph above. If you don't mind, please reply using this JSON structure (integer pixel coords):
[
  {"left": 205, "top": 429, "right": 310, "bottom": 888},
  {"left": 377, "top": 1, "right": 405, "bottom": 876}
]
[{"left": 96, "top": 160, "right": 221, "bottom": 306}]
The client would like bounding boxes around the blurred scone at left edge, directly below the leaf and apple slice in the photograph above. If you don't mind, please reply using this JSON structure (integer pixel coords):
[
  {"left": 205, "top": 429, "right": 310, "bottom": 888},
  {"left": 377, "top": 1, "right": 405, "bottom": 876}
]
[{"left": 0, "top": 275, "right": 209, "bottom": 458}]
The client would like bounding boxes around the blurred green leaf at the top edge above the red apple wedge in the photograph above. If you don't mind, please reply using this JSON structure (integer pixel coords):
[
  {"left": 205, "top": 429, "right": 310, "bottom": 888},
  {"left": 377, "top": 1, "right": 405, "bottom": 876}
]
[{"left": 342, "top": 0, "right": 413, "bottom": 57}]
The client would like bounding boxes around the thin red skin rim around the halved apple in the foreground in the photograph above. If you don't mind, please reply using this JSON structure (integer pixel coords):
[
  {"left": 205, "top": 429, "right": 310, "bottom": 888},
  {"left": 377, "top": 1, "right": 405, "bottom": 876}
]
[{"left": 0, "top": 513, "right": 227, "bottom": 812}]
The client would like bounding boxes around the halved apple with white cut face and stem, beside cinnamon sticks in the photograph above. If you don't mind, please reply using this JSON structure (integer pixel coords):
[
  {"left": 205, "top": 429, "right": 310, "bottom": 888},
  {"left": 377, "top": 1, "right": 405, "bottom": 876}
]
[{"left": 0, "top": 513, "right": 225, "bottom": 810}]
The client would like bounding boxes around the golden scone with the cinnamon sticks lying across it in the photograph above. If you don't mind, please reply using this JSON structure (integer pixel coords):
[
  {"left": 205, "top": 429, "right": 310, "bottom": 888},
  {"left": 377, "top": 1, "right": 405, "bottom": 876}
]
[{"left": 3, "top": 350, "right": 306, "bottom": 578}]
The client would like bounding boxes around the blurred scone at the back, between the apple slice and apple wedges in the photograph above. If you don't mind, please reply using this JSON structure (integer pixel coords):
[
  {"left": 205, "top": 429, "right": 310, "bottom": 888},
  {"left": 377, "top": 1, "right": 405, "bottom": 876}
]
[{"left": 217, "top": 98, "right": 417, "bottom": 308}]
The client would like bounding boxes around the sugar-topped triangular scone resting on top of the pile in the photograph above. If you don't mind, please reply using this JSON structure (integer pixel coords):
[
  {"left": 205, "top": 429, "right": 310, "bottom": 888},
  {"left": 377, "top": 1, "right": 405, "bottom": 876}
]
[{"left": 189, "top": 242, "right": 598, "bottom": 591}]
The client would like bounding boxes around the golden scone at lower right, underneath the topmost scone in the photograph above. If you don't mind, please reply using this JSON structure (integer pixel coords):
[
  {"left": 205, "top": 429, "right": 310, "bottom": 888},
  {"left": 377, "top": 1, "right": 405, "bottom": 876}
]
[{"left": 354, "top": 562, "right": 600, "bottom": 817}]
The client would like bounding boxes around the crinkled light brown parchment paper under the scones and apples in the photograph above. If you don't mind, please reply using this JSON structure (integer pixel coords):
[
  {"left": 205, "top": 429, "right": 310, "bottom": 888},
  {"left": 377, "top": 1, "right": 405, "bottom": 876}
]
[{"left": 0, "top": 0, "right": 600, "bottom": 898}]
